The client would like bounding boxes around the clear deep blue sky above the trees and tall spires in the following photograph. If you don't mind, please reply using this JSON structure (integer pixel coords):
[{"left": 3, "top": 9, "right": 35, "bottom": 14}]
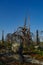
[{"left": 0, "top": 0, "right": 43, "bottom": 39}]
